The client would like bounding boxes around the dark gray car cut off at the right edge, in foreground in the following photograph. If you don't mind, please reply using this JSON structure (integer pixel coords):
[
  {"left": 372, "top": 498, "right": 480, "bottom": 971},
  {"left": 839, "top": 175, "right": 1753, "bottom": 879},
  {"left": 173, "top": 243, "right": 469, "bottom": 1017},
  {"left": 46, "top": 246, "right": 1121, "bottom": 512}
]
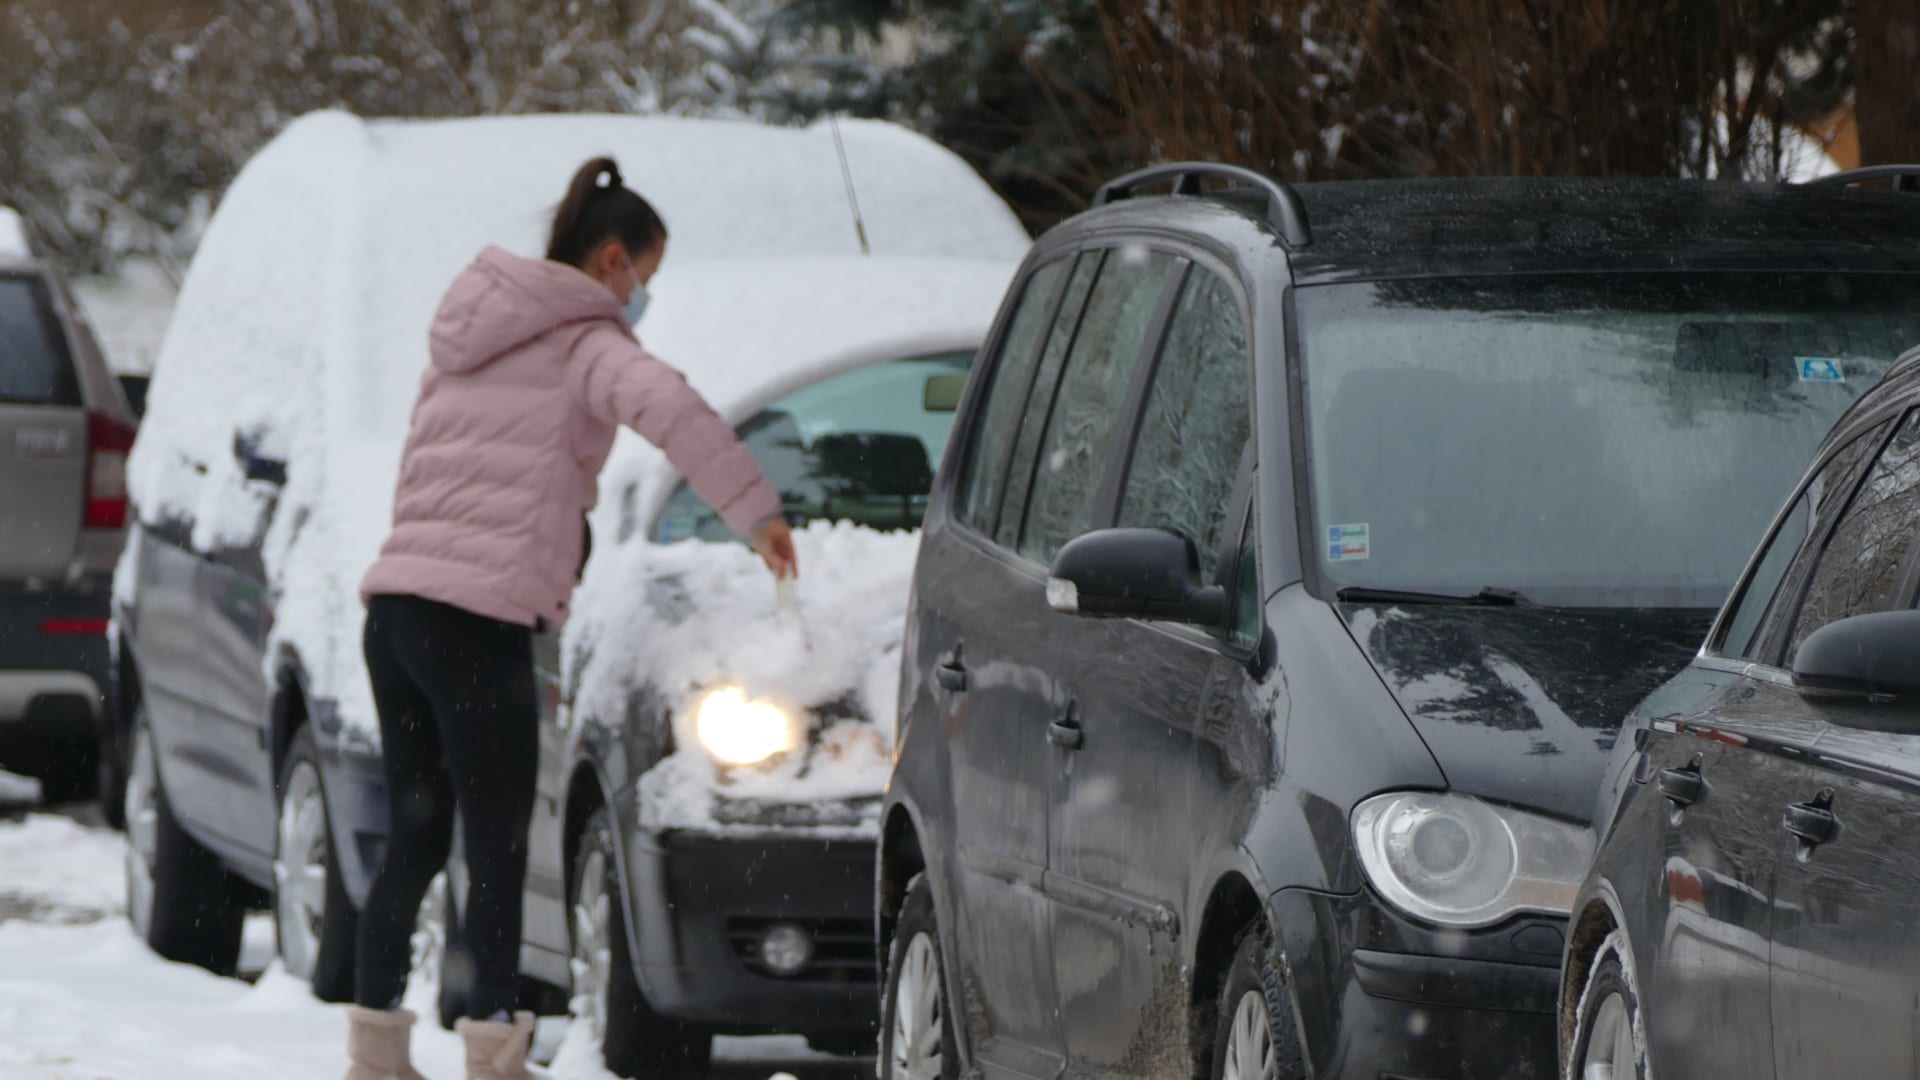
[{"left": 1561, "top": 342, "right": 1920, "bottom": 1080}]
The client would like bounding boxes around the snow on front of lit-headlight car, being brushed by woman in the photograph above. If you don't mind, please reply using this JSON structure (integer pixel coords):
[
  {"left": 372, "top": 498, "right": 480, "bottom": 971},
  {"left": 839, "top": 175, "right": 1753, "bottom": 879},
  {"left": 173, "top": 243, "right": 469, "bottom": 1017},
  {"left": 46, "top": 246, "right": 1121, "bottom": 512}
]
[{"left": 564, "top": 523, "right": 920, "bottom": 836}]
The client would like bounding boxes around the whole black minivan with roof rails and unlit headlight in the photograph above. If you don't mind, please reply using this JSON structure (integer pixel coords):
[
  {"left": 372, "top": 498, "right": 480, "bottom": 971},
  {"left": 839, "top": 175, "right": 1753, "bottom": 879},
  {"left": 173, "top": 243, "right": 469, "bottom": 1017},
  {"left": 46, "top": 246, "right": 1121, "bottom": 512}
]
[{"left": 877, "top": 165, "right": 1920, "bottom": 1080}]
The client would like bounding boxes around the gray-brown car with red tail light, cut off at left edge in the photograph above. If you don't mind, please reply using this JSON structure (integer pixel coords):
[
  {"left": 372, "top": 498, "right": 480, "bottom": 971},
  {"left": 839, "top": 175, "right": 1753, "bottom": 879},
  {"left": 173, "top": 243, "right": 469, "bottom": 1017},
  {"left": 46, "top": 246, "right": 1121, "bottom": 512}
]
[{"left": 0, "top": 209, "right": 134, "bottom": 805}]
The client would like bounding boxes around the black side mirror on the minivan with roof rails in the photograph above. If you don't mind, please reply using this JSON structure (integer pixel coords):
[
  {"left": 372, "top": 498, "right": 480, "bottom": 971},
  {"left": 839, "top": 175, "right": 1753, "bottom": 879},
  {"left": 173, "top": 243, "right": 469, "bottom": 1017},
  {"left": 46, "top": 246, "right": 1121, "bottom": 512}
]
[{"left": 1046, "top": 528, "right": 1227, "bottom": 628}]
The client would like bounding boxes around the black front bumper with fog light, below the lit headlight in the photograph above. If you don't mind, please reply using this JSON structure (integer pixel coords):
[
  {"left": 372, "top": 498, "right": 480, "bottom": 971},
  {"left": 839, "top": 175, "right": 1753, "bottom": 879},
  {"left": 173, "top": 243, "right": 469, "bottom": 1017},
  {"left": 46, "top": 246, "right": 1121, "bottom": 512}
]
[{"left": 626, "top": 830, "right": 879, "bottom": 1036}]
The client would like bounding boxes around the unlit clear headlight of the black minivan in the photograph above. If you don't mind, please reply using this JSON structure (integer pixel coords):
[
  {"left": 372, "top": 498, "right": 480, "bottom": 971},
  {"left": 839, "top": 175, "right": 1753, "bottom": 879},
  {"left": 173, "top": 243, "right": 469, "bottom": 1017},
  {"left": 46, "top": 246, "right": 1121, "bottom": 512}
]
[{"left": 1354, "top": 792, "right": 1594, "bottom": 928}]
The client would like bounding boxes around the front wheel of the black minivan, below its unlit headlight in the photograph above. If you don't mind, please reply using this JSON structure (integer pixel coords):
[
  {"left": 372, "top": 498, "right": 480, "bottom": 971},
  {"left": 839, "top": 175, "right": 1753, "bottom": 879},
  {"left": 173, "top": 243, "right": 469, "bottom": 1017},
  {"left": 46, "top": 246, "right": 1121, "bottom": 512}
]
[{"left": 1212, "top": 922, "right": 1308, "bottom": 1080}]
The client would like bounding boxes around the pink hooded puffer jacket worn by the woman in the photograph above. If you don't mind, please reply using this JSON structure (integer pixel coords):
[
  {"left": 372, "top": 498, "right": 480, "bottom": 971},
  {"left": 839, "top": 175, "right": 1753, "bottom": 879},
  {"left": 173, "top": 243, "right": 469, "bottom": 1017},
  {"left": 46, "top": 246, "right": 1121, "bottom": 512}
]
[{"left": 361, "top": 248, "right": 780, "bottom": 628}]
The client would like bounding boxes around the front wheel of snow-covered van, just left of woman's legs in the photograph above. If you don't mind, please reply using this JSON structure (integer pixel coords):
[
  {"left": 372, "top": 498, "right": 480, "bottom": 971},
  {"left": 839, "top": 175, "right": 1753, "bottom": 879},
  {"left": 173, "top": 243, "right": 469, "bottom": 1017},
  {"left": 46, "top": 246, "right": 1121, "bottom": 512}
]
[{"left": 273, "top": 726, "right": 359, "bottom": 1003}]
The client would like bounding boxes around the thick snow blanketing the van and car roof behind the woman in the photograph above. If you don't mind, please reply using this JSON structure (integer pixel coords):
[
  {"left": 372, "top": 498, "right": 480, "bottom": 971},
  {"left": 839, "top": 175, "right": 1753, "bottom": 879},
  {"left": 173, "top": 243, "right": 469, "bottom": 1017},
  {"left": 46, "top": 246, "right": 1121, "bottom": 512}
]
[{"left": 129, "top": 113, "right": 1027, "bottom": 738}]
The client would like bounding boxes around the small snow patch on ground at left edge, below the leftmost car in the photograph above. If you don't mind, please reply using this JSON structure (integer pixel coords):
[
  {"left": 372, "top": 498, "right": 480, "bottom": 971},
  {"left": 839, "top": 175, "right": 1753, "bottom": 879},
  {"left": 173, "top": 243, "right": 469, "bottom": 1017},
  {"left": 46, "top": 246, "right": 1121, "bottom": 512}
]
[{"left": 0, "top": 813, "right": 127, "bottom": 922}]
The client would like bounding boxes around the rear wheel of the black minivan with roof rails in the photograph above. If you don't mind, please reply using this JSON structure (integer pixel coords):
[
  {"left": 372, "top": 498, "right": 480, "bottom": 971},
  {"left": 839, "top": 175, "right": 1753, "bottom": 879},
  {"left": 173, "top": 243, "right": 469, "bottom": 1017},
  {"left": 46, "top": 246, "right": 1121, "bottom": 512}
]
[{"left": 879, "top": 876, "right": 960, "bottom": 1080}]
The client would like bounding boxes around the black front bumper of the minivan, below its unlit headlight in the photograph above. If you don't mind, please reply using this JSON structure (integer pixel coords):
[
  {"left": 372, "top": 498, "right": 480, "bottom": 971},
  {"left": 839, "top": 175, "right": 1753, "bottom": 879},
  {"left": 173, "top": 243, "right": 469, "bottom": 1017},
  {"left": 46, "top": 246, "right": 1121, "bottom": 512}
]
[{"left": 1269, "top": 890, "right": 1565, "bottom": 1080}]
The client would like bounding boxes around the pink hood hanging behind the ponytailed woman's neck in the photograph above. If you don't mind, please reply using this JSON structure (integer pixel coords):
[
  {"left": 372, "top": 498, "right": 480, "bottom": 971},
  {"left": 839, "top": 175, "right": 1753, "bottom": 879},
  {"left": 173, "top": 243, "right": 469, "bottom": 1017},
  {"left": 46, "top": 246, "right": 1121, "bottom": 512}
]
[{"left": 432, "top": 248, "right": 628, "bottom": 375}]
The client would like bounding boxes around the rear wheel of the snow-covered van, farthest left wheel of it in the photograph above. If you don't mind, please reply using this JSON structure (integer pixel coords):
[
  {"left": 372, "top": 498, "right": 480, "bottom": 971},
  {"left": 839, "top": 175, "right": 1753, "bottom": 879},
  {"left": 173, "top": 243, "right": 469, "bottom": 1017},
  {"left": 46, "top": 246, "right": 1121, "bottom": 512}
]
[{"left": 125, "top": 709, "right": 246, "bottom": 974}]
